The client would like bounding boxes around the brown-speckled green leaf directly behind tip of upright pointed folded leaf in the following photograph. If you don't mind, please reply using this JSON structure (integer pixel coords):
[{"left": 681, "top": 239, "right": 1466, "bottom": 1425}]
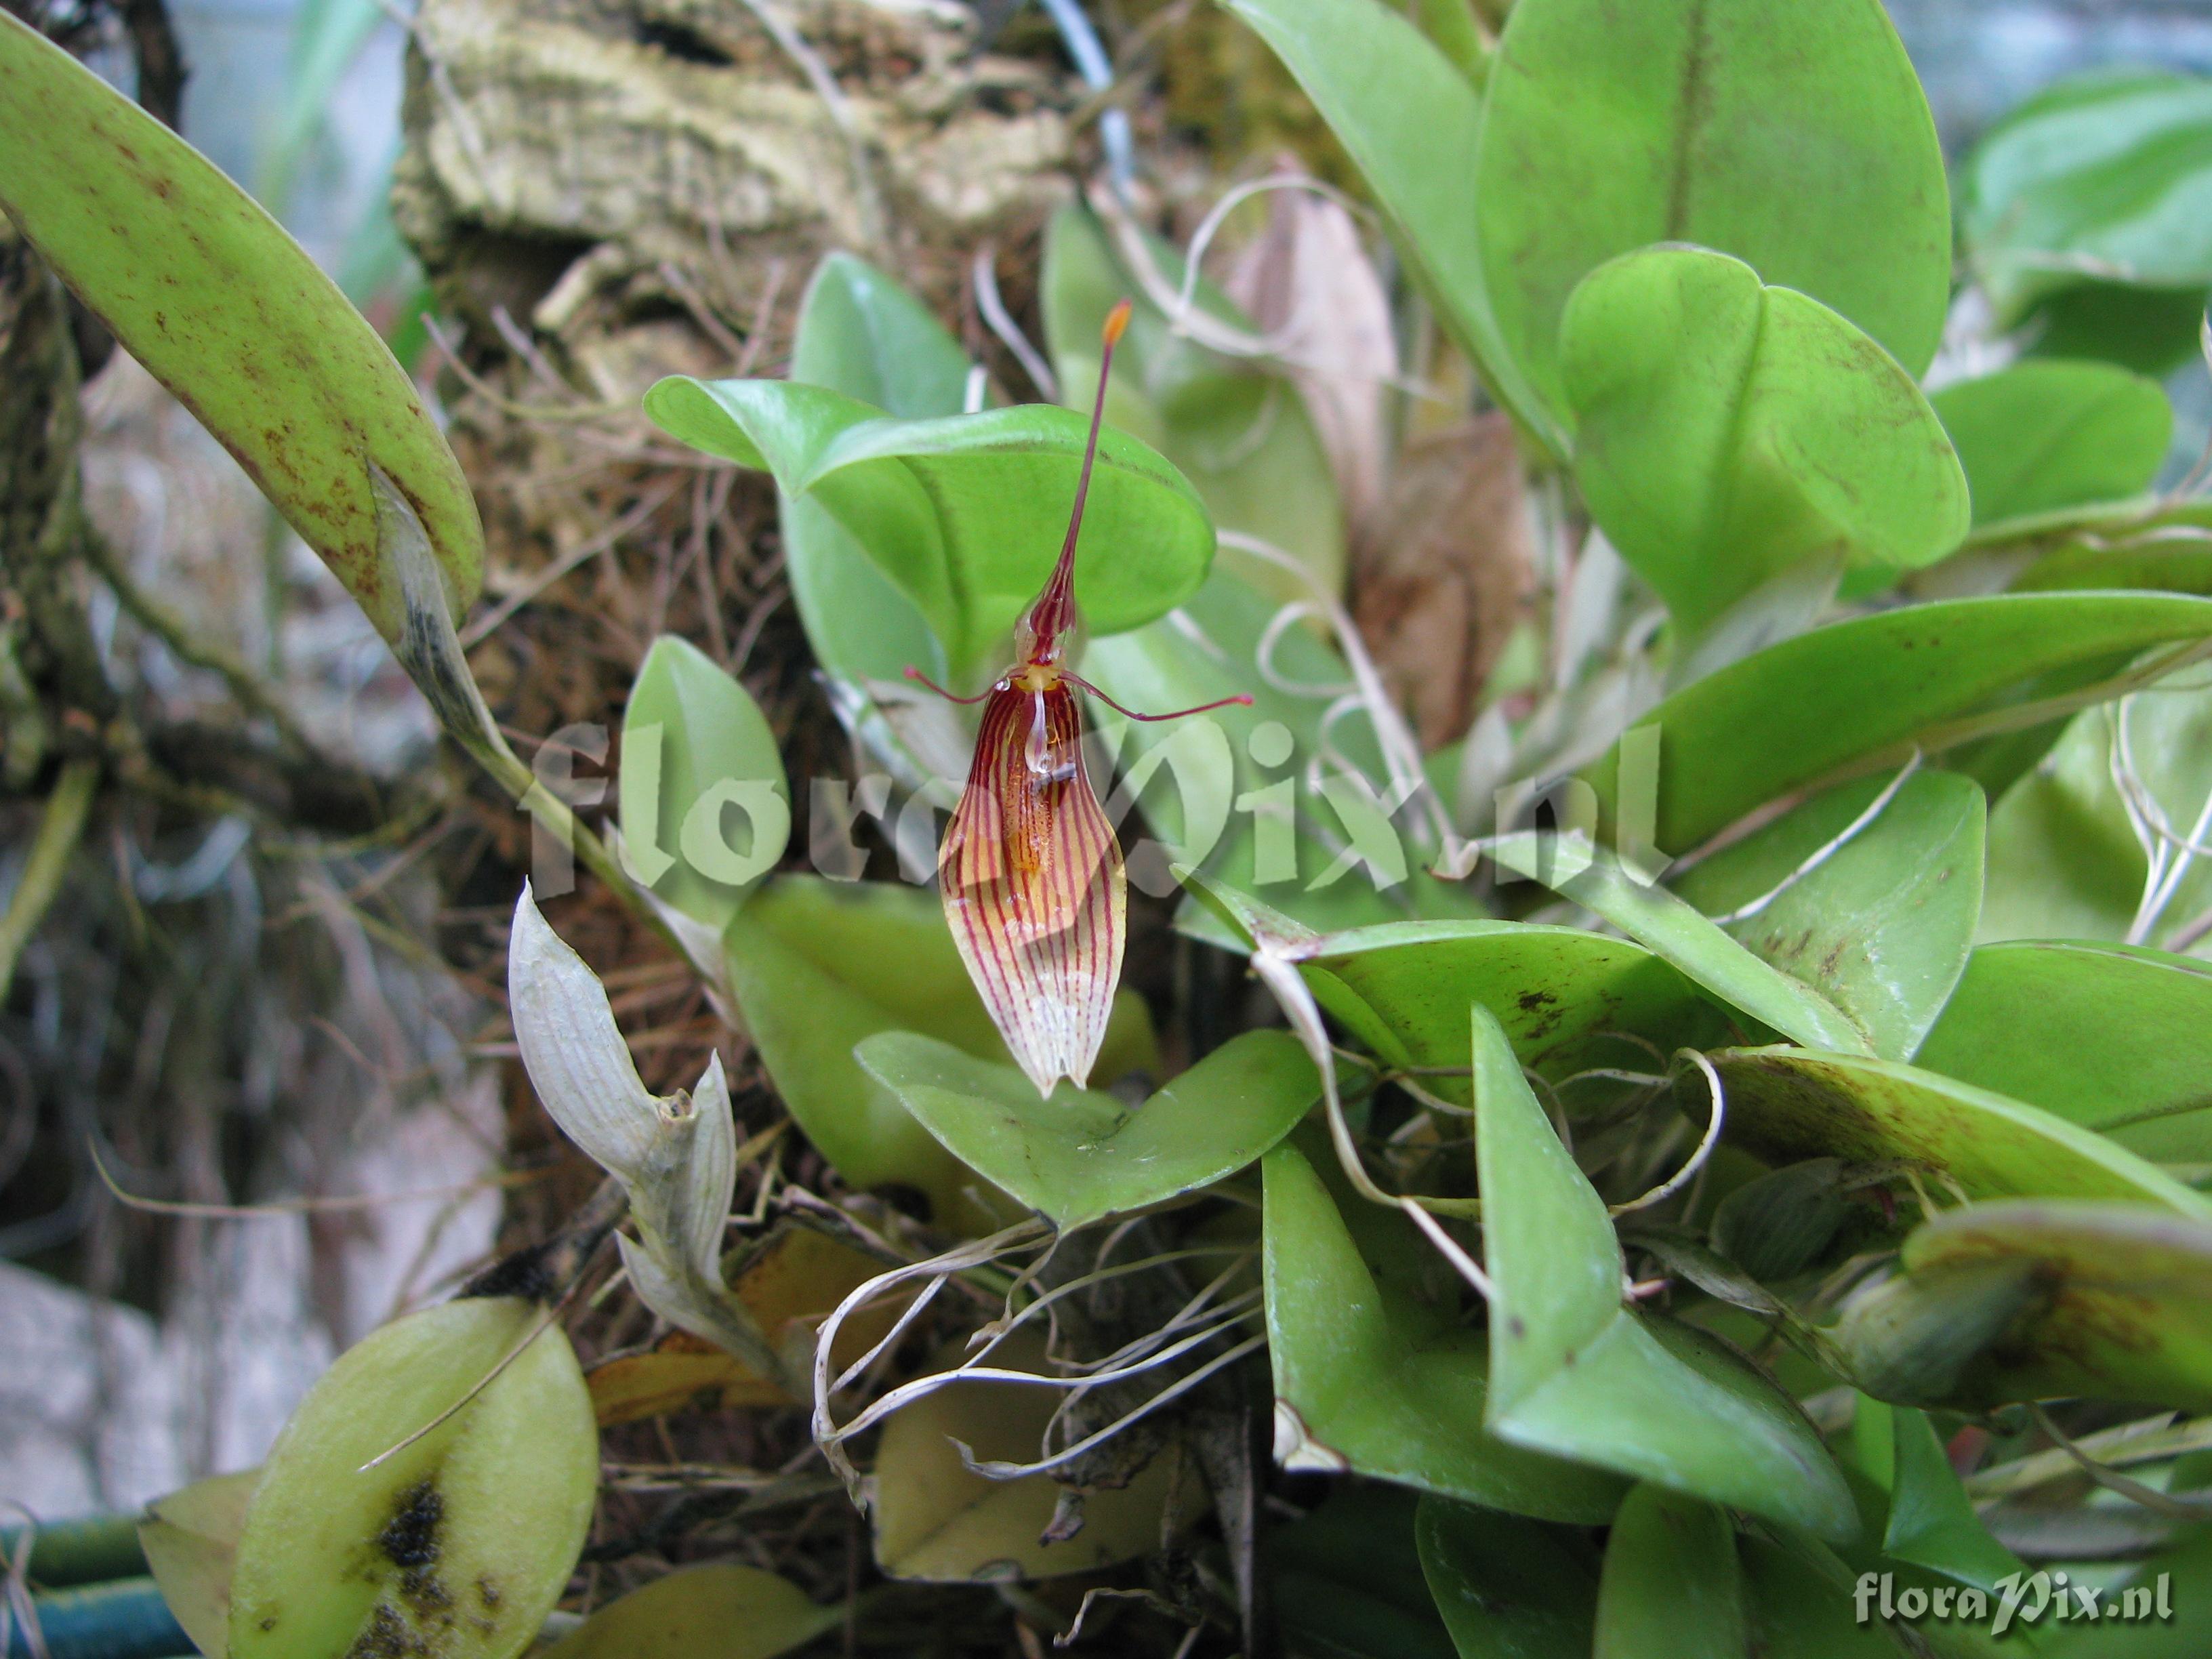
[{"left": 1298, "top": 920, "right": 1725, "bottom": 1099}]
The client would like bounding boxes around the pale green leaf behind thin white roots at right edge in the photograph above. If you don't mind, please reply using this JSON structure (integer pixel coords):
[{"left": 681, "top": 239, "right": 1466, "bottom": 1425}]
[{"left": 1980, "top": 688, "right": 2212, "bottom": 949}]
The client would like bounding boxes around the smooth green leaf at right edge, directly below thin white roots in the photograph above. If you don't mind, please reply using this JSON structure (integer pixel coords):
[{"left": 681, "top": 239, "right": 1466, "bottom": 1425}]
[{"left": 1916, "top": 940, "right": 2212, "bottom": 1164}]
